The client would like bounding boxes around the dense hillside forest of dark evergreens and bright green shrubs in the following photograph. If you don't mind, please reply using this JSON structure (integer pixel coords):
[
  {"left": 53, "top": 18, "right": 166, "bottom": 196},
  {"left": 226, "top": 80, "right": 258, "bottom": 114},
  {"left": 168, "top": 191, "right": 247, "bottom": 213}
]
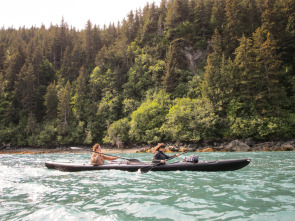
[{"left": 0, "top": 0, "right": 295, "bottom": 146}]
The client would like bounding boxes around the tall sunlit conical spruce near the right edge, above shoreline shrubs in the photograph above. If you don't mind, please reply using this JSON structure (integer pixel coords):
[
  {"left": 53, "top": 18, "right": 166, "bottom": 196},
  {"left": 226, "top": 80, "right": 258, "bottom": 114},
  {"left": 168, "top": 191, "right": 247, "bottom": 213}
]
[{"left": 253, "top": 28, "right": 286, "bottom": 114}]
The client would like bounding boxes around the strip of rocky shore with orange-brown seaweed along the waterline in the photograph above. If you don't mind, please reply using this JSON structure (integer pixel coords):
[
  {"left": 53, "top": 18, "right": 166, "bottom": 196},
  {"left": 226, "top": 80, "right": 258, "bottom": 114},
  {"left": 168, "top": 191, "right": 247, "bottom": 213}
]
[{"left": 0, "top": 138, "right": 295, "bottom": 154}]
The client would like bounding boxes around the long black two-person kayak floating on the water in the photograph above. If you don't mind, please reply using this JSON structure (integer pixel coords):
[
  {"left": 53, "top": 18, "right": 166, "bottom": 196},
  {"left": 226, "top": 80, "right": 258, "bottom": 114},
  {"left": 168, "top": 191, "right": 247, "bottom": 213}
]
[{"left": 45, "top": 159, "right": 251, "bottom": 172}]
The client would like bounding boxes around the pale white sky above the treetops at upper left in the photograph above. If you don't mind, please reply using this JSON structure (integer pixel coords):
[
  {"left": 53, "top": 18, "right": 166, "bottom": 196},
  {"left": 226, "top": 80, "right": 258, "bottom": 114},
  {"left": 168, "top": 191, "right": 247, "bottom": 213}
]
[{"left": 0, "top": 0, "right": 161, "bottom": 30}]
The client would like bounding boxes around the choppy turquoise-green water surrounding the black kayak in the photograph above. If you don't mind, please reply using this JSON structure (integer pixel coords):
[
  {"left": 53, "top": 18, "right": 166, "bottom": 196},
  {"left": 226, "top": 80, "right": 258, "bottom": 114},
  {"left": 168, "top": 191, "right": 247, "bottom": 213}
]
[{"left": 0, "top": 152, "right": 295, "bottom": 221}]
